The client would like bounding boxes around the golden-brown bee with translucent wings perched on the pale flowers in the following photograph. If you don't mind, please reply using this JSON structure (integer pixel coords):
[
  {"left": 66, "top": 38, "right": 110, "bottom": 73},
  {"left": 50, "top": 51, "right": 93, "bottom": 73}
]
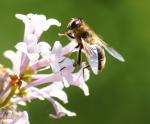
[{"left": 59, "top": 18, "right": 125, "bottom": 75}]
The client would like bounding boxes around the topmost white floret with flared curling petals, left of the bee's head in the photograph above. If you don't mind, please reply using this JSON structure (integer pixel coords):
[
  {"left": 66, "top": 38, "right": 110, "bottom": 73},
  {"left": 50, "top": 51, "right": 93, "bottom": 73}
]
[{"left": 16, "top": 13, "right": 61, "bottom": 41}]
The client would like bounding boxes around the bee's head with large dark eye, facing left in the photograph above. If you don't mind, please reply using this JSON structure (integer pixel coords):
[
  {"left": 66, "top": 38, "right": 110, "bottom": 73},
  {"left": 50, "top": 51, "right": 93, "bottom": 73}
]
[{"left": 67, "top": 18, "right": 82, "bottom": 30}]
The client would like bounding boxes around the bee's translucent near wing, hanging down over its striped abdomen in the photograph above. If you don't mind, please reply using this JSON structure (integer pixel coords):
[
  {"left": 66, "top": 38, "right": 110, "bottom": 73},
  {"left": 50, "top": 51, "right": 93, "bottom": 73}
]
[{"left": 82, "top": 40, "right": 99, "bottom": 75}]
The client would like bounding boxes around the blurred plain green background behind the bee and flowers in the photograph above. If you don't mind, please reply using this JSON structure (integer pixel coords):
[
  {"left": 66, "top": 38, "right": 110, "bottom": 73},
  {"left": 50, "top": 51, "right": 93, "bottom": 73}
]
[{"left": 0, "top": 0, "right": 150, "bottom": 124}]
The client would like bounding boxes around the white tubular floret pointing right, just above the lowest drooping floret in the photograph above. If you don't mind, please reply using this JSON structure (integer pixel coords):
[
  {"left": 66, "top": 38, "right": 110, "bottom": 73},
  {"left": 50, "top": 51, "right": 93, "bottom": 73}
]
[{"left": 16, "top": 82, "right": 68, "bottom": 104}]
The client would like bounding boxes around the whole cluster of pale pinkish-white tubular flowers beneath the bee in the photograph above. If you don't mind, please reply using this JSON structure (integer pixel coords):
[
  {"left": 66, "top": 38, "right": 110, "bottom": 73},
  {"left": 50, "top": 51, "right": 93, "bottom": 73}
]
[{"left": 0, "top": 14, "right": 89, "bottom": 124}]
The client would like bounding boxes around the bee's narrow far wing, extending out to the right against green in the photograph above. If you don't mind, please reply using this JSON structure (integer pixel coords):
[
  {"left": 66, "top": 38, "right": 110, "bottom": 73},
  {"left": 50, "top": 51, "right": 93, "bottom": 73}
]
[{"left": 100, "top": 40, "right": 125, "bottom": 62}]
